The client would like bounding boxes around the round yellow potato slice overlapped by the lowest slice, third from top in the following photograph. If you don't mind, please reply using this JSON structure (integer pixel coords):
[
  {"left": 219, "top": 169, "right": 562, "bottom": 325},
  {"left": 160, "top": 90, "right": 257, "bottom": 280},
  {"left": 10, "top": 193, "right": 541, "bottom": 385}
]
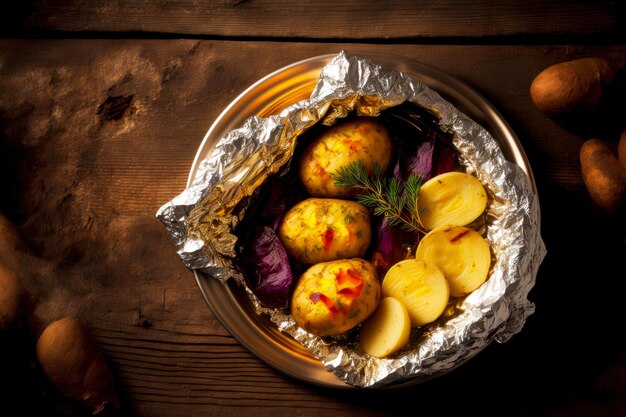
[{"left": 382, "top": 259, "right": 450, "bottom": 327}]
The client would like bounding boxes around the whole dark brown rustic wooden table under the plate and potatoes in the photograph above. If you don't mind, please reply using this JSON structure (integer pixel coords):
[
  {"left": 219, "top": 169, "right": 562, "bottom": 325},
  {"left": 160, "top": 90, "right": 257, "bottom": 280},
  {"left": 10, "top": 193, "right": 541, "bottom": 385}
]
[{"left": 0, "top": 0, "right": 626, "bottom": 417}]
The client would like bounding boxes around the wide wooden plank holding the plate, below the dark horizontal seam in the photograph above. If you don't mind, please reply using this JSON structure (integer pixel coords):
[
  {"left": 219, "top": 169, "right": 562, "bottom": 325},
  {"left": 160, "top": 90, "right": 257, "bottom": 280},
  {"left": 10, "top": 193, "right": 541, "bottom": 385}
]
[{"left": 0, "top": 39, "right": 626, "bottom": 417}]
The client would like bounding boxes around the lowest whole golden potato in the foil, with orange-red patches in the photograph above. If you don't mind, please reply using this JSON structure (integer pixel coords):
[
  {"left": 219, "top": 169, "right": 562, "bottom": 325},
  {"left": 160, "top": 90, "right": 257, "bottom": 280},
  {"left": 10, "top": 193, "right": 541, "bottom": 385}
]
[{"left": 291, "top": 258, "right": 380, "bottom": 336}]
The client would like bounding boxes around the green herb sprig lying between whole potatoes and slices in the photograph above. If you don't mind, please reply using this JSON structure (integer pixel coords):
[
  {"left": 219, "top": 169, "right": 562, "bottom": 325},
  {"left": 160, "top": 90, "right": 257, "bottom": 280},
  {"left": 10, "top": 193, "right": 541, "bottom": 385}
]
[{"left": 332, "top": 159, "right": 426, "bottom": 232}]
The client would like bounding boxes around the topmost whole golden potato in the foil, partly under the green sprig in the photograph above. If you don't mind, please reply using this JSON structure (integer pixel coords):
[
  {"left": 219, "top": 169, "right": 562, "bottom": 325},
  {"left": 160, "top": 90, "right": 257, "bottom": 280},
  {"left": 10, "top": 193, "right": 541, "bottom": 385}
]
[{"left": 299, "top": 118, "right": 392, "bottom": 197}]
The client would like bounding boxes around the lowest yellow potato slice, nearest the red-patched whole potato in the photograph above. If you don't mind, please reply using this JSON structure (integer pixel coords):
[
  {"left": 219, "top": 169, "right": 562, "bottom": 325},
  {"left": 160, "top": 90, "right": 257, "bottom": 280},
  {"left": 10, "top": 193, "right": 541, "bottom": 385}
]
[{"left": 359, "top": 297, "right": 411, "bottom": 358}]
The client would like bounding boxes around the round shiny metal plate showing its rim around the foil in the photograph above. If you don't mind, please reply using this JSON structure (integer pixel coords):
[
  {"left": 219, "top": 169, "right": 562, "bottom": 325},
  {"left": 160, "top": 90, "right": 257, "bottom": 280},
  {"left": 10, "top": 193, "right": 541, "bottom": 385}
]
[{"left": 187, "top": 54, "right": 536, "bottom": 388}]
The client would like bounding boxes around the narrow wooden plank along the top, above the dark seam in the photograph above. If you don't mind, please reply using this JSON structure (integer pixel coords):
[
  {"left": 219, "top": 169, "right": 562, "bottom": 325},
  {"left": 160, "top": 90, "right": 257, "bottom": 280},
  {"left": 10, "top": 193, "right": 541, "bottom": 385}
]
[{"left": 4, "top": 0, "right": 623, "bottom": 41}]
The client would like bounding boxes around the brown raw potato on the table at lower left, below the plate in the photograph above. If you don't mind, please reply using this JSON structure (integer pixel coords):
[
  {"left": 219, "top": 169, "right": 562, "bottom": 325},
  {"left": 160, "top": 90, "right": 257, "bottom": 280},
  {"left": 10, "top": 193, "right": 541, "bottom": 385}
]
[{"left": 36, "top": 317, "right": 119, "bottom": 413}]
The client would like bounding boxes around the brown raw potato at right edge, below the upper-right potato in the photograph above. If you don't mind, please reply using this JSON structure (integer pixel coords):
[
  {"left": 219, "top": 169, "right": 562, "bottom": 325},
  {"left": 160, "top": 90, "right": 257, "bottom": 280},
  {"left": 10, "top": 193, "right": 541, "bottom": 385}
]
[{"left": 580, "top": 139, "right": 626, "bottom": 212}]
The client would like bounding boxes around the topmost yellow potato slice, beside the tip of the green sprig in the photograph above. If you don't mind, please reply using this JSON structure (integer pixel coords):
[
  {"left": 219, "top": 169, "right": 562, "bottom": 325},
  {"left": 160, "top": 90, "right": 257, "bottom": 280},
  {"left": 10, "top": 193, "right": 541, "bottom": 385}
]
[{"left": 417, "top": 172, "right": 487, "bottom": 230}]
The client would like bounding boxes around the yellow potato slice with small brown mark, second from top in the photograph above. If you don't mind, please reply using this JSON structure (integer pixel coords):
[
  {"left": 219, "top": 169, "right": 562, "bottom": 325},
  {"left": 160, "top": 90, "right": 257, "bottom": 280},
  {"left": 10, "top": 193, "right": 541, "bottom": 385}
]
[{"left": 415, "top": 226, "right": 491, "bottom": 297}]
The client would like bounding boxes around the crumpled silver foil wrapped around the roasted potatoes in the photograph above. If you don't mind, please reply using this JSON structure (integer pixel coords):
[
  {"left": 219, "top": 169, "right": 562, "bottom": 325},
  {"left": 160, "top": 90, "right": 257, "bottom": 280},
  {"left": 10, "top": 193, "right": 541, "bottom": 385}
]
[{"left": 157, "top": 52, "right": 546, "bottom": 387}]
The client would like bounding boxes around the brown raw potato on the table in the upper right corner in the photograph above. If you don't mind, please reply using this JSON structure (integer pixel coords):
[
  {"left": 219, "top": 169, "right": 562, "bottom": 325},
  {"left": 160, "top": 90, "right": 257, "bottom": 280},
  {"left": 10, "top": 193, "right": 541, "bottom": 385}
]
[{"left": 530, "top": 58, "right": 615, "bottom": 113}]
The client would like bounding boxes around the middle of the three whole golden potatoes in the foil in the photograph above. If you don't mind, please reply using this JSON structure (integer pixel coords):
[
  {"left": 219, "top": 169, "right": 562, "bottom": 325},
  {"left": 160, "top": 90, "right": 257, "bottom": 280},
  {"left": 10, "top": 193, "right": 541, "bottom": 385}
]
[{"left": 278, "top": 198, "right": 372, "bottom": 264}]
